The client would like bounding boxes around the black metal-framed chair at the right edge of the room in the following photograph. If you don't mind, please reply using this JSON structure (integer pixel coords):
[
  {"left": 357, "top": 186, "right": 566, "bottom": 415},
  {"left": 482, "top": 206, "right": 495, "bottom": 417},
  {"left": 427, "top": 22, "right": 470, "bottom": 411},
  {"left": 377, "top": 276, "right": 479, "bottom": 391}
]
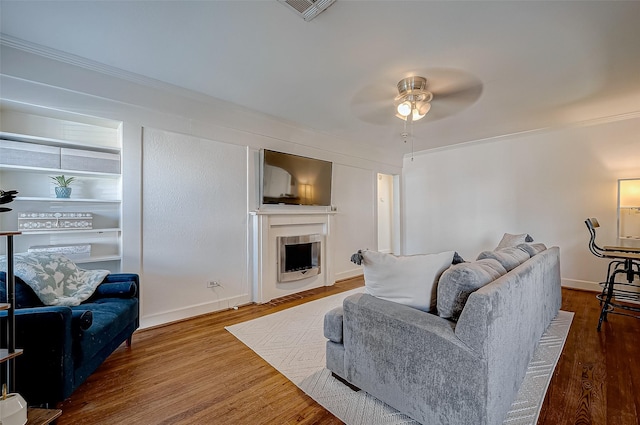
[{"left": 584, "top": 218, "right": 640, "bottom": 331}]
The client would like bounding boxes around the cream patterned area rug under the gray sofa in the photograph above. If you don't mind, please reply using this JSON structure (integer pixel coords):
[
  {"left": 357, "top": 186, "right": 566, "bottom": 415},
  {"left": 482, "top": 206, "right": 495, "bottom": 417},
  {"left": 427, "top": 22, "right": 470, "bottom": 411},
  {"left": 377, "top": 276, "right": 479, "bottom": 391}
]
[{"left": 226, "top": 288, "right": 573, "bottom": 425}]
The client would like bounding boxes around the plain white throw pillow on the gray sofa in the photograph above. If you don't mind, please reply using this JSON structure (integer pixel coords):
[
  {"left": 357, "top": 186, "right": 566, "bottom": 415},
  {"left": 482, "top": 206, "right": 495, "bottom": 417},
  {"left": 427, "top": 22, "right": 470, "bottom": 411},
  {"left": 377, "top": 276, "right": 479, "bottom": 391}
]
[{"left": 362, "top": 251, "right": 454, "bottom": 311}]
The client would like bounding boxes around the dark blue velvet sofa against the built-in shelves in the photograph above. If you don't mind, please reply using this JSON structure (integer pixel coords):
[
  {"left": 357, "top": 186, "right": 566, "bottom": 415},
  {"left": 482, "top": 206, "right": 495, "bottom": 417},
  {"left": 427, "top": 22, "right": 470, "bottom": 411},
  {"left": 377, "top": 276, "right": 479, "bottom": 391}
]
[{"left": 0, "top": 272, "right": 140, "bottom": 405}]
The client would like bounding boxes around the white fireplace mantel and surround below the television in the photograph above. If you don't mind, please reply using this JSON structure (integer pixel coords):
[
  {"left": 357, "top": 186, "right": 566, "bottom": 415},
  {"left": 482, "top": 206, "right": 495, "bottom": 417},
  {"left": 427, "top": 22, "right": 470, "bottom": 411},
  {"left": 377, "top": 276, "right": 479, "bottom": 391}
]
[{"left": 250, "top": 208, "right": 336, "bottom": 304}]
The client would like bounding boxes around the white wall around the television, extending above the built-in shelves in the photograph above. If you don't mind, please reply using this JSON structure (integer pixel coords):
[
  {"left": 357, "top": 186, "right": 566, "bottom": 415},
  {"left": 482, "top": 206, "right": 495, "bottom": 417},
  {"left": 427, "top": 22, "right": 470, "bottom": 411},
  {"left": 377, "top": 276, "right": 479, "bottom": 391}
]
[{"left": 0, "top": 45, "right": 400, "bottom": 327}]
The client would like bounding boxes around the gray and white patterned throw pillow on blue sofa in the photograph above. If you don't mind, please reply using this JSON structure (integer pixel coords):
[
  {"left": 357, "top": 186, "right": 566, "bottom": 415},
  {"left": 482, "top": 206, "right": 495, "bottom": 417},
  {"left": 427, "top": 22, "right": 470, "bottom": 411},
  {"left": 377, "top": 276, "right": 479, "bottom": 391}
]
[{"left": 0, "top": 253, "right": 109, "bottom": 306}]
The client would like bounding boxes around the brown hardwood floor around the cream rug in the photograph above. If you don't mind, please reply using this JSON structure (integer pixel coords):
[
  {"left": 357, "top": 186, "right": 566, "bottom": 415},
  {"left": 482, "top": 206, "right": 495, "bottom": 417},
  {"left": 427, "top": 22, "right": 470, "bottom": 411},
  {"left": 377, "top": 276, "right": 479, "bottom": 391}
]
[{"left": 57, "top": 278, "right": 640, "bottom": 425}]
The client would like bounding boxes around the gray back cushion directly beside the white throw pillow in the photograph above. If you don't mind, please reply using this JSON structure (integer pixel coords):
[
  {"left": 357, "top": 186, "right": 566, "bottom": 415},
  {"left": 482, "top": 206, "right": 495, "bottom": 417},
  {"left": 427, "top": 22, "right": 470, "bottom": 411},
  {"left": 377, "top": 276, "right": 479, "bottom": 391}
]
[{"left": 437, "top": 258, "right": 507, "bottom": 320}]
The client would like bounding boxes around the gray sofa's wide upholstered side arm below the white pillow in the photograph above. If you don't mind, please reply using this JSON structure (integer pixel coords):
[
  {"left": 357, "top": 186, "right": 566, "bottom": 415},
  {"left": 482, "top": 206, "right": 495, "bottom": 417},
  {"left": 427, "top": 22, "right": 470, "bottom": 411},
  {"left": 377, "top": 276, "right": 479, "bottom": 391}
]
[{"left": 343, "top": 294, "right": 486, "bottom": 424}]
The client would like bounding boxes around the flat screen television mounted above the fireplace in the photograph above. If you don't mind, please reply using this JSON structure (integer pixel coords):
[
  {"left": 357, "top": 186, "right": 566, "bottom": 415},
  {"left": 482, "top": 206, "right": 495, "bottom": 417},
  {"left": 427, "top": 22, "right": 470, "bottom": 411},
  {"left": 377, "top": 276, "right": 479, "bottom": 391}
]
[{"left": 260, "top": 149, "right": 333, "bottom": 206}]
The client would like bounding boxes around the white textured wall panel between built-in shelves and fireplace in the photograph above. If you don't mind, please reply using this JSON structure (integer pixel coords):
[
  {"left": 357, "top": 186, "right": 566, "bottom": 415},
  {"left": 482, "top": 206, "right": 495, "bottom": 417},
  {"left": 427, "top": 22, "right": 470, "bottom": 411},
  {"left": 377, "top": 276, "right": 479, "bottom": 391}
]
[{"left": 142, "top": 128, "right": 251, "bottom": 324}]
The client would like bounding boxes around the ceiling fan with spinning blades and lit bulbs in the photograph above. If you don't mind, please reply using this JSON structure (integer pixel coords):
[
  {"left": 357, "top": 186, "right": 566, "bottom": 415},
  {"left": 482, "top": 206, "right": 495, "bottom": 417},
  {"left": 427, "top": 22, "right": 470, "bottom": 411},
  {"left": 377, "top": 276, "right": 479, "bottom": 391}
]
[{"left": 351, "top": 68, "right": 482, "bottom": 125}]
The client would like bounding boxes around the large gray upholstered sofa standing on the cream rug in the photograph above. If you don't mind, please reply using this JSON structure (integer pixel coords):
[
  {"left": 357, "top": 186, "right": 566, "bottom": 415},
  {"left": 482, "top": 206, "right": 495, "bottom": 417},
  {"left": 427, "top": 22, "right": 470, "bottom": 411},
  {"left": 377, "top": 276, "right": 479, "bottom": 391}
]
[{"left": 324, "top": 243, "right": 561, "bottom": 425}]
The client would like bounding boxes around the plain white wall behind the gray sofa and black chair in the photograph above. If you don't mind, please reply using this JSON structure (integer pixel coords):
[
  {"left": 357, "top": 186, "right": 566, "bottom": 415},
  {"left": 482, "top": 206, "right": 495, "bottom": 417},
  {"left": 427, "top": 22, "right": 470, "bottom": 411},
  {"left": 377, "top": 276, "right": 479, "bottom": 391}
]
[{"left": 403, "top": 116, "right": 640, "bottom": 289}]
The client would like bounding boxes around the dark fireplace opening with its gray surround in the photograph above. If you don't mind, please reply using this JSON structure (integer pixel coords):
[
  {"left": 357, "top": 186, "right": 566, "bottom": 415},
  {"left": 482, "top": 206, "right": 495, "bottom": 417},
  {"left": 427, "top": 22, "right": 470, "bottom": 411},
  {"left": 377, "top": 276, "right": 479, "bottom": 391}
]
[{"left": 278, "top": 234, "right": 322, "bottom": 282}]
